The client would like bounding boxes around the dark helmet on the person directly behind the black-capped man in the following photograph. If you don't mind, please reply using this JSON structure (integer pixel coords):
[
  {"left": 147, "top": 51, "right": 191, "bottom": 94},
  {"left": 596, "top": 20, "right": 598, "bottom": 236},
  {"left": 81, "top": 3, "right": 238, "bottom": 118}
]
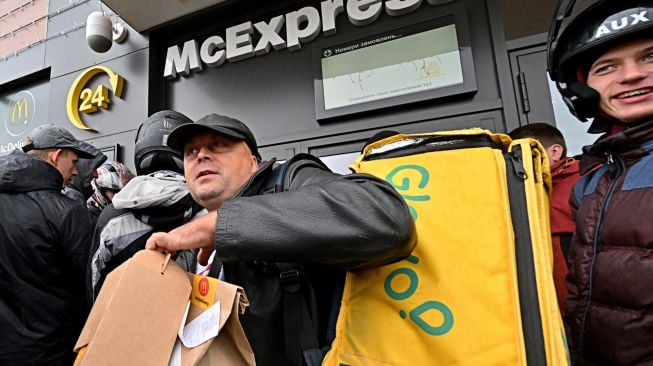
[{"left": 134, "top": 110, "right": 193, "bottom": 175}]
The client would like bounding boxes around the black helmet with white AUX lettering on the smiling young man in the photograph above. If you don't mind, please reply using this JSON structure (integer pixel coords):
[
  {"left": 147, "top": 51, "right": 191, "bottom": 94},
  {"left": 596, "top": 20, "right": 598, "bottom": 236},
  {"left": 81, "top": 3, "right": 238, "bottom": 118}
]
[{"left": 547, "top": 0, "right": 653, "bottom": 121}]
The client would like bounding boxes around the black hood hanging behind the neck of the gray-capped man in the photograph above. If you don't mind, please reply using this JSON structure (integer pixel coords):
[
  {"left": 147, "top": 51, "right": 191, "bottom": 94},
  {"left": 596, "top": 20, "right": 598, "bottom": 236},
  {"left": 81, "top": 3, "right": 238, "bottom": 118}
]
[{"left": 0, "top": 150, "right": 63, "bottom": 192}]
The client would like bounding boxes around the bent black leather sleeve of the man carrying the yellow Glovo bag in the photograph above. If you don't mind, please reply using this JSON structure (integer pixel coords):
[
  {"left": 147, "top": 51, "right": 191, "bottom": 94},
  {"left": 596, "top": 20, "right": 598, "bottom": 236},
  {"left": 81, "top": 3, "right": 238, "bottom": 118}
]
[{"left": 215, "top": 167, "right": 416, "bottom": 270}]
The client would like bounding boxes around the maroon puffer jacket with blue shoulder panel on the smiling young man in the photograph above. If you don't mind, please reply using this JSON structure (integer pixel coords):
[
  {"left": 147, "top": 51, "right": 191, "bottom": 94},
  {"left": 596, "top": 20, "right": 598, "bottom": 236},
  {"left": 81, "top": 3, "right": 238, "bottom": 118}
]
[{"left": 565, "top": 121, "right": 653, "bottom": 365}]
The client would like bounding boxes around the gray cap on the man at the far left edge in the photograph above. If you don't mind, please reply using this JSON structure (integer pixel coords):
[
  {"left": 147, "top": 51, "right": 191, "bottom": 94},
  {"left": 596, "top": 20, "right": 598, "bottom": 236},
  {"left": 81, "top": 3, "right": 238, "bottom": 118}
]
[{"left": 23, "top": 125, "right": 95, "bottom": 159}]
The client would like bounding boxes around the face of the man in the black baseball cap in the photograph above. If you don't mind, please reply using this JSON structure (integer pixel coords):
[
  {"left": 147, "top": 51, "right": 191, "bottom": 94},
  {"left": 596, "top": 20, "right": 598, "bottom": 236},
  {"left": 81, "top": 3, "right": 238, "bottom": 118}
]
[{"left": 184, "top": 132, "right": 258, "bottom": 211}]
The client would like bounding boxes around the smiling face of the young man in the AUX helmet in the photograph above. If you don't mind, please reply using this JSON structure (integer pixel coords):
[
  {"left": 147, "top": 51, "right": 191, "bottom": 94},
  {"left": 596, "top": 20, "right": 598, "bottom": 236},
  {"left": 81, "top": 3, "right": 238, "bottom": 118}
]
[{"left": 587, "top": 39, "right": 653, "bottom": 123}]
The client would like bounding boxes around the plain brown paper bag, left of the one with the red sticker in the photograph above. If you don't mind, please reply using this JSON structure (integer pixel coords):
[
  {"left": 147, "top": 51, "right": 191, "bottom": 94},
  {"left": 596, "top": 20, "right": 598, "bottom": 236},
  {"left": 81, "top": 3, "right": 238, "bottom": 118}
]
[{"left": 75, "top": 250, "right": 191, "bottom": 366}]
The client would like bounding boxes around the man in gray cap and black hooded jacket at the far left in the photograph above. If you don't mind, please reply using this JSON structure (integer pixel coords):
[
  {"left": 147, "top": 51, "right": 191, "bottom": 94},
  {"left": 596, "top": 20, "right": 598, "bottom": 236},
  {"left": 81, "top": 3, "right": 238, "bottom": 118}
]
[{"left": 0, "top": 126, "right": 93, "bottom": 365}]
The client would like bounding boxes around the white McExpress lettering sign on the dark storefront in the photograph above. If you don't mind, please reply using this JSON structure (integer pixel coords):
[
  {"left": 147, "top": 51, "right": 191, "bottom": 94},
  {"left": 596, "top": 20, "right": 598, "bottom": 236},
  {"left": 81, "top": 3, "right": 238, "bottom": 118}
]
[{"left": 163, "top": 0, "right": 453, "bottom": 79}]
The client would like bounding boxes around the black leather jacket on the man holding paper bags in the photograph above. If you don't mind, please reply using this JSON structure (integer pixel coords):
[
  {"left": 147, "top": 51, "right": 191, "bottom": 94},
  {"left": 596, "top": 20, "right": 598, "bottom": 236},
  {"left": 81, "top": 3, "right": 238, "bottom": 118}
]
[{"left": 214, "top": 162, "right": 416, "bottom": 366}]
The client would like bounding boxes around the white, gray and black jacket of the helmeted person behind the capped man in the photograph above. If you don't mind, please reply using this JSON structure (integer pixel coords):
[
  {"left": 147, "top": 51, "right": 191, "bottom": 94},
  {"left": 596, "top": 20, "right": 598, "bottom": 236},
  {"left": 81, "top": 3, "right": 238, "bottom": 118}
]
[{"left": 87, "top": 170, "right": 206, "bottom": 301}]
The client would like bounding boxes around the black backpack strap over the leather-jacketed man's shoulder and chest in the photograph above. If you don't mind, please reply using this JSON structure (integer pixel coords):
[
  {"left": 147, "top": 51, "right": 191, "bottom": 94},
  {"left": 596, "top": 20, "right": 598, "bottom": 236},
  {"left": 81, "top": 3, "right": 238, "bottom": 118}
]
[{"left": 273, "top": 153, "right": 330, "bottom": 366}]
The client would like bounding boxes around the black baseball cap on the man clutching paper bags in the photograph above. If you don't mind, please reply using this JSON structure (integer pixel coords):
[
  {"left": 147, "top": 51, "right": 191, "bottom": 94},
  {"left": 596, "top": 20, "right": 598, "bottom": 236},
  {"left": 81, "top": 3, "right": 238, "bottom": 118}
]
[{"left": 167, "top": 113, "right": 261, "bottom": 159}]
